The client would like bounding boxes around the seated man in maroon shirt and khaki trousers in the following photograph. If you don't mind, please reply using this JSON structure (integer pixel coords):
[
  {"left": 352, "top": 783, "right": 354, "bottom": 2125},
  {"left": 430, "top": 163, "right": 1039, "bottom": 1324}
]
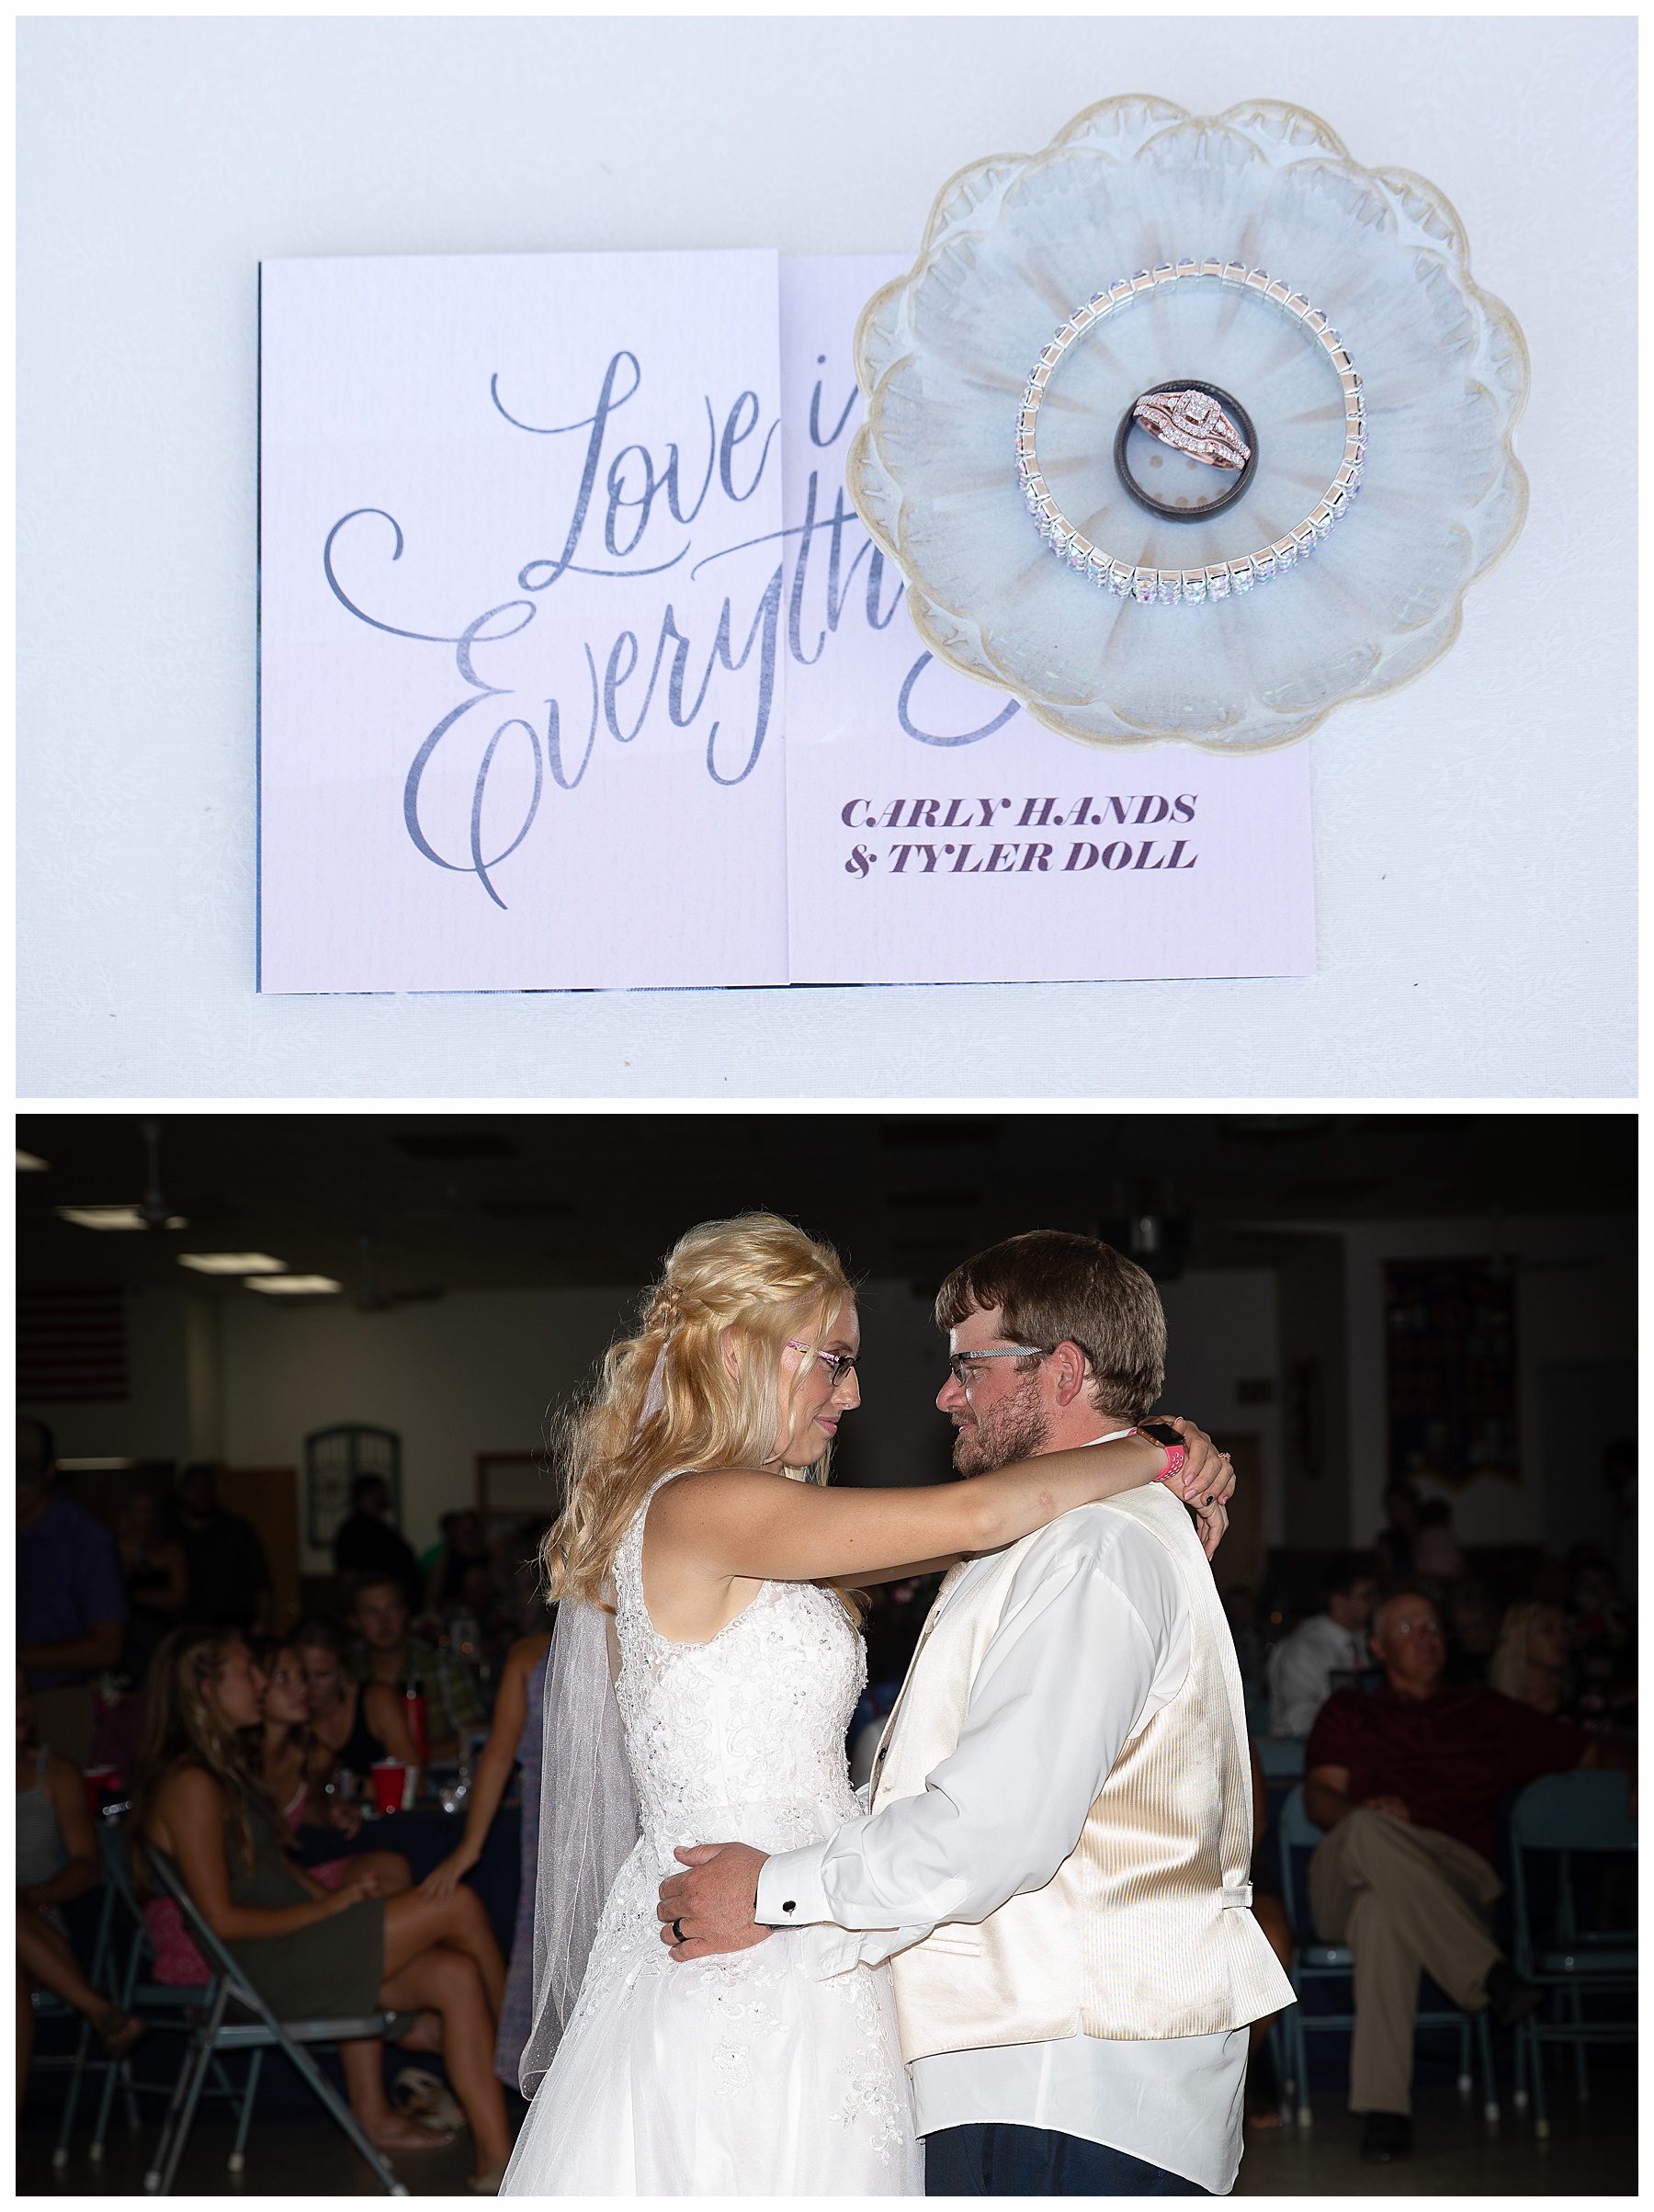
[{"left": 1305, "top": 1591, "right": 1634, "bottom": 2165}]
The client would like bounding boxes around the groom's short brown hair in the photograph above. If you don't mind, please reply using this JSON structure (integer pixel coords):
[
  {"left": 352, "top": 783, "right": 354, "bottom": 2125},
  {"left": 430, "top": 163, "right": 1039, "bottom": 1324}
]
[{"left": 935, "top": 1230, "right": 1165, "bottom": 1420}]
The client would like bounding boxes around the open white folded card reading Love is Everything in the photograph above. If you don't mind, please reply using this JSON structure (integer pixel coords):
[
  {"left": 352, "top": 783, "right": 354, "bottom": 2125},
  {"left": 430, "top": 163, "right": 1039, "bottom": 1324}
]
[{"left": 259, "top": 252, "right": 1313, "bottom": 991}]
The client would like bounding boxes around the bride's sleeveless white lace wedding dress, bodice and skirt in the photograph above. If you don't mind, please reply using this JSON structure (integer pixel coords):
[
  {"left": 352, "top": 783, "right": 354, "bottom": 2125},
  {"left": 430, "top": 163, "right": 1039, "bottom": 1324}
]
[{"left": 502, "top": 1475, "right": 924, "bottom": 2196}]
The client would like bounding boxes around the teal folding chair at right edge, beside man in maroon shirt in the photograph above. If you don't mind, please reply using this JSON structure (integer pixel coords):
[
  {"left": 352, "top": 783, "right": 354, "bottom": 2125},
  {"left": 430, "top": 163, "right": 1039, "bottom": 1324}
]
[{"left": 1511, "top": 1770, "right": 1637, "bottom": 2135}]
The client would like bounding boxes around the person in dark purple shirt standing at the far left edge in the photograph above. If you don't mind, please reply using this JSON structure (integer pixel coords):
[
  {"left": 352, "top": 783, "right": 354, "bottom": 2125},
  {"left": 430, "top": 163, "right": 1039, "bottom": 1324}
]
[{"left": 17, "top": 1413, "right": 126, "bottom": 1767}]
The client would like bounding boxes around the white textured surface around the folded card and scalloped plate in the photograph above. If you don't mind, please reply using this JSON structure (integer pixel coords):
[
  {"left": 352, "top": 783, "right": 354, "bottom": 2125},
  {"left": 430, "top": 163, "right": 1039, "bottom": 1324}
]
[{"left": 17, "top": 16, "right": 1637, "bottom": 1097}]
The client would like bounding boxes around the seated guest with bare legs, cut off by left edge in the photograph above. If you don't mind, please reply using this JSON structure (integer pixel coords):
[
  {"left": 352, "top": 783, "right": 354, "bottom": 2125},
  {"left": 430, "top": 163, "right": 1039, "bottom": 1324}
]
[{"left": 17, "top": 1668, "right": 146, "bottom": 2113}]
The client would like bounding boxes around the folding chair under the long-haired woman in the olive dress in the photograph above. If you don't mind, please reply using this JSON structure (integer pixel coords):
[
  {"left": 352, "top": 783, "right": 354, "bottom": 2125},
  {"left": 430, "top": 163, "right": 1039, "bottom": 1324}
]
[{"left": 143, "top": 1844, "right": 407, "bottom": 2196}]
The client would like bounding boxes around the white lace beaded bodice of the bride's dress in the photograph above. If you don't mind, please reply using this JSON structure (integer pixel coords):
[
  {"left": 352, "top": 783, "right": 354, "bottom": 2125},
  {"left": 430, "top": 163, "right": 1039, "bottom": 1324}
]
[{"left": 615, "top": 1475, "right": 867, "bottom": 1865}]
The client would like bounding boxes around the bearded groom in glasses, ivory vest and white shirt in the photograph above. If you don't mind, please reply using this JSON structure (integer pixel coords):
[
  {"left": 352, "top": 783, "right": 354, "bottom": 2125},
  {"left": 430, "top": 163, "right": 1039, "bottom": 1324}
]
[{"left": 659, "top": 1230, "right": 1291, "bottom": 2196}]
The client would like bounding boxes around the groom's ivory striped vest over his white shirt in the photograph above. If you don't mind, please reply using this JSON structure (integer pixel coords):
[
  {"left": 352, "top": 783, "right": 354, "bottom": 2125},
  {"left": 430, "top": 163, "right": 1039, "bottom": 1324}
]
[{"left": 871, "top": 1484, "right": 1291, "bottom": 2064}]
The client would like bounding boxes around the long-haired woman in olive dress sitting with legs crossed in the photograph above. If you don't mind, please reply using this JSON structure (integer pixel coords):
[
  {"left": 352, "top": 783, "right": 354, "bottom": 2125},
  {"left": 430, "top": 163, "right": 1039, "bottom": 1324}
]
[{"left": 132, "top": 1628, "right": 511, "bottom": 2195}]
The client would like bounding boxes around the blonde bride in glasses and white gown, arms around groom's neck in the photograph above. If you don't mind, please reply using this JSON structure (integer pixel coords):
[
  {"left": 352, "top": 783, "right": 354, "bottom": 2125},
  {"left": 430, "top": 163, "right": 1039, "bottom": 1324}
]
[{"left": 502, "top": 1214, "right": 1231, "bottom": 2196}]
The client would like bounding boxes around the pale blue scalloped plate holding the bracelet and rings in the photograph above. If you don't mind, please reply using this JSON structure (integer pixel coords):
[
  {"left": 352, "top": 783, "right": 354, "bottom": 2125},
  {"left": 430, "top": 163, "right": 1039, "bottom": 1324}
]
[{"left": 849, "top": 97, "right": 1528, "bottom": 752}]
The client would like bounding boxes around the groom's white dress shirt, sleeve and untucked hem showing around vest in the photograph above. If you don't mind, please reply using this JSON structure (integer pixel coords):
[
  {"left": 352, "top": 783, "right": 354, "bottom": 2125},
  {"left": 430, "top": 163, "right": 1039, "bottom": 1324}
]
[{"left": 756, "top": 1486, "right": 1247, "bottom": 2195}]
